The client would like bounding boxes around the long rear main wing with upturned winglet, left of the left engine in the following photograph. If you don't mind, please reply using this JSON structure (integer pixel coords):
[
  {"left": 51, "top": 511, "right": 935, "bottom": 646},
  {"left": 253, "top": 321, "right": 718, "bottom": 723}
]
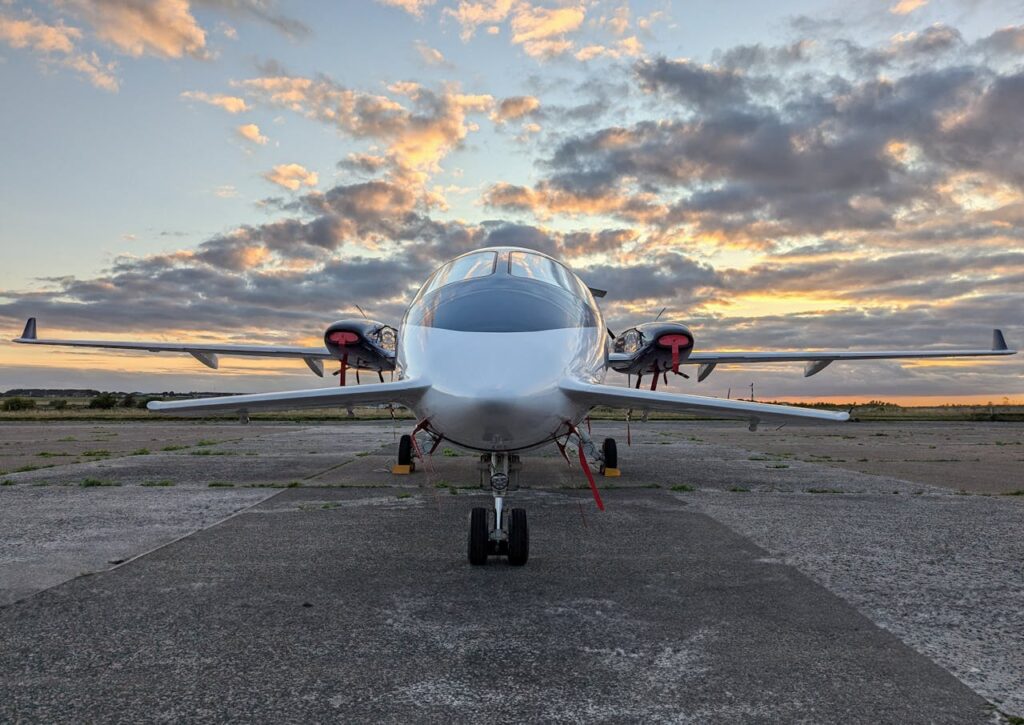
[{"left": 12, "top": 317, "right": 334, "bottom": 378}]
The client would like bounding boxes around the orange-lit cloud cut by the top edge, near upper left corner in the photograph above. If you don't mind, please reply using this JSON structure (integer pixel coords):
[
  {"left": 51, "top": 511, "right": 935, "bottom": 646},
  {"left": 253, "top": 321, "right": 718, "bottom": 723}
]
[{"left": 69, "top": 0, "right": 209, "bottom": 58}]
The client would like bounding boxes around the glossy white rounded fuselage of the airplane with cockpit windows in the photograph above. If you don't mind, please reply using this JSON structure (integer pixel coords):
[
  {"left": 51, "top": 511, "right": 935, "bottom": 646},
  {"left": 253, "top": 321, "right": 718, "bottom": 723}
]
[{"left": 397, "top": 248, "right": 608, "bottom": 452}]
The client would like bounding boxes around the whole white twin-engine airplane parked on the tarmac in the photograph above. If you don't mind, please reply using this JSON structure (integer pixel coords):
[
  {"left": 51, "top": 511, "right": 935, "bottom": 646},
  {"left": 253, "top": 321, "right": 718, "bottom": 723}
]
[{"left": 14, "top": 247, "right": 1016, "bottom": 566}]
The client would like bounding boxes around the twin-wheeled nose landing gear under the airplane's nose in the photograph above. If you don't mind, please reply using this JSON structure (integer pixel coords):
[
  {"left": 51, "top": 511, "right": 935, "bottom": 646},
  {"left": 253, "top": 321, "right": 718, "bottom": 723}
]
[{"left": 468, "top": 453, "right": 529, "bottom": 566}]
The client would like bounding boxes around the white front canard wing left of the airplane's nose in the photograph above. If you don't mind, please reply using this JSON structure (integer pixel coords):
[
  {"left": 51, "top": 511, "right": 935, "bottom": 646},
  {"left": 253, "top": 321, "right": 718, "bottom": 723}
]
[{"left": 146, "top": 378, "right": 430, "bottom": 415}]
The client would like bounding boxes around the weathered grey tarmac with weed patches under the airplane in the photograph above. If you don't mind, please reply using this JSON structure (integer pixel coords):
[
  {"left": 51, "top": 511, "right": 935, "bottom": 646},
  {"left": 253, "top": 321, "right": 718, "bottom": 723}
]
[{"left": 0, "top": 415, "right": 1024, "bottom": 723}]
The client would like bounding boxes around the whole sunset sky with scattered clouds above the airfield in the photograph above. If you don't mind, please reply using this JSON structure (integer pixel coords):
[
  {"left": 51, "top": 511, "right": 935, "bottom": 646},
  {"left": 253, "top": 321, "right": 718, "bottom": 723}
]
[{"left": 0, "top": 0, "right": 1024, "bottom": 403}]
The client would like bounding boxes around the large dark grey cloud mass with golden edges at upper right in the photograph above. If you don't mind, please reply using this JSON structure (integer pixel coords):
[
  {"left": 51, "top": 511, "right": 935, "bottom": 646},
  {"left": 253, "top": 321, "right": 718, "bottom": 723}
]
[{"left": 483, "top": 31, "right": 1024, "bottom": 250}]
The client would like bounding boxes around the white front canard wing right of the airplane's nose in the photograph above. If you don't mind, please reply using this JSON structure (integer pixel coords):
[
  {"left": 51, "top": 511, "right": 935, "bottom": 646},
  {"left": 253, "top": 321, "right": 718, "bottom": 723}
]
[{"left": 560, "top": 379, "right": 850, "bottom": 427}]
